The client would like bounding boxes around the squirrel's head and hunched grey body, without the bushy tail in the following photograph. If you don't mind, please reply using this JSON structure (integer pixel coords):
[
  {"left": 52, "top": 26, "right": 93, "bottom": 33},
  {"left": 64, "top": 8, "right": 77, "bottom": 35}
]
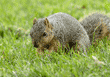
[{"left": 30, "top": 13, "right": 90, "bottom": 52}]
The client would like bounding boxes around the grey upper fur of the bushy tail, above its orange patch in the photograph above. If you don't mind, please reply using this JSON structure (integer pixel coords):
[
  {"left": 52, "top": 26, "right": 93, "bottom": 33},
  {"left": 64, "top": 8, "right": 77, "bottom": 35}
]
[{"left": 80, "top": 13, "right": 110, "bottom": 43}]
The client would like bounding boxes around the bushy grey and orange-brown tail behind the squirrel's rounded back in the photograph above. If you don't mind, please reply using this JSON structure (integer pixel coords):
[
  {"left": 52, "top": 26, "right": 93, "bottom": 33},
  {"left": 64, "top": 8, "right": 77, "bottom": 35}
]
[{"left": 80, "top": 13, "right": 110, "bottom": 44}]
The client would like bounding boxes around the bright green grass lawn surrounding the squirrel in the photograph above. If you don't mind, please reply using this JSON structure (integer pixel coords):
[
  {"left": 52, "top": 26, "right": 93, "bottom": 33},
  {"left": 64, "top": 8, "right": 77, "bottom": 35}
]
[{"left": 0, "top": 0, "right": 110, "bottom": 77}]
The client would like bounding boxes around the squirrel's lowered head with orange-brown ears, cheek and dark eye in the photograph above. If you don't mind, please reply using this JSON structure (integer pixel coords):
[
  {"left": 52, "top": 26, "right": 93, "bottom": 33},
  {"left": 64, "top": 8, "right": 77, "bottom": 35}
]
[{"left": 30, "top": 18, "right": 54, "bottom": 48}]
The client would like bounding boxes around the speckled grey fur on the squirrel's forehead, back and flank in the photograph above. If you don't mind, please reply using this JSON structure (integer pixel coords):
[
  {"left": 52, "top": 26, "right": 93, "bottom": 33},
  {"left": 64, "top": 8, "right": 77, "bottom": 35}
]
[{"left": 30, "top": 13, "right": 90, "bottom": 51}]
